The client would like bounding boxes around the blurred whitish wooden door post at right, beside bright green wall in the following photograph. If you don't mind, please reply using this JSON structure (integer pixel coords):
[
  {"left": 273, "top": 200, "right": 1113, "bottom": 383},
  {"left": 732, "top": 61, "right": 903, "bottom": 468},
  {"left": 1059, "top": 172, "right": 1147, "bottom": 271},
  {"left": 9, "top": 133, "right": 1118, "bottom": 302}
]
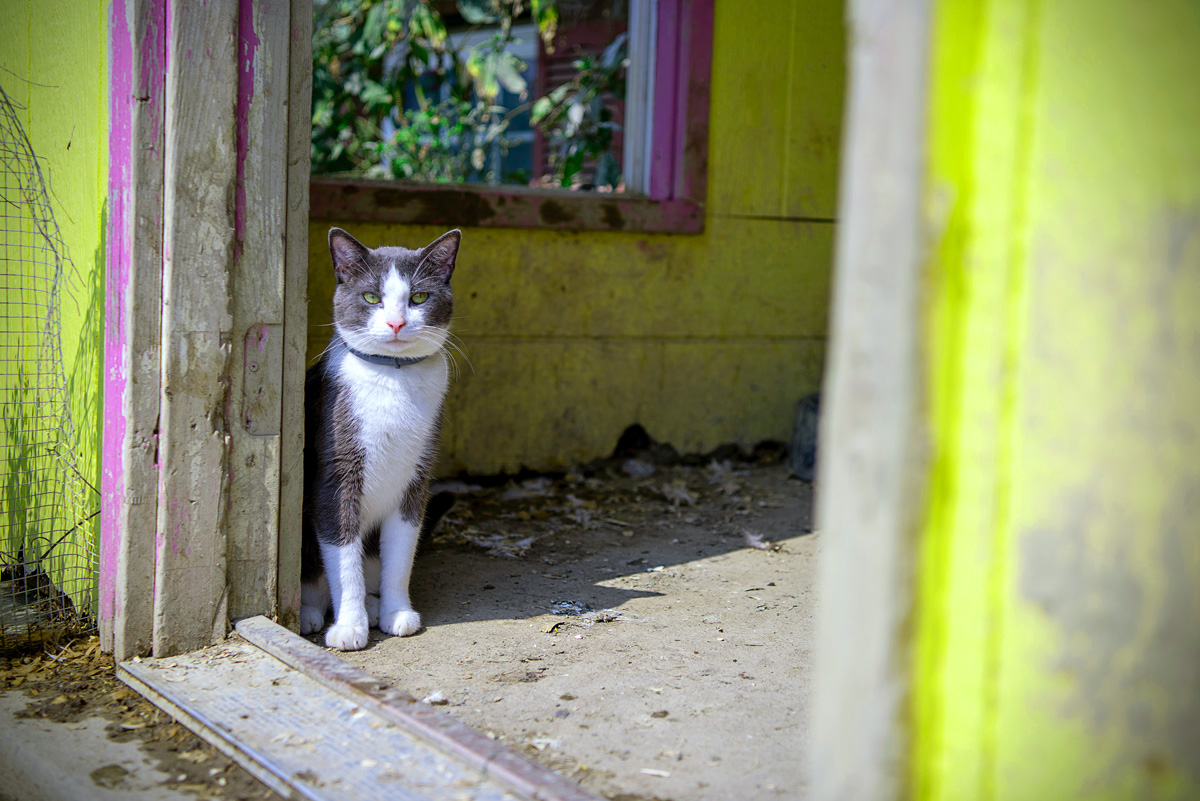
[{"left": 809, "top": 0, "right": 932, "bottom": 801}]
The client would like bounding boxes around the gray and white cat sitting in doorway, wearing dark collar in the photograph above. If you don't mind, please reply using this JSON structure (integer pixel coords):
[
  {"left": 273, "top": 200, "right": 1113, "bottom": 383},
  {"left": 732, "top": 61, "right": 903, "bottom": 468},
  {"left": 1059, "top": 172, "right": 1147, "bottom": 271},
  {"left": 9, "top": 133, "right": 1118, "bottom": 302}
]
[{"left": 300, "top": 228, "right": 462, "bottom": 651}]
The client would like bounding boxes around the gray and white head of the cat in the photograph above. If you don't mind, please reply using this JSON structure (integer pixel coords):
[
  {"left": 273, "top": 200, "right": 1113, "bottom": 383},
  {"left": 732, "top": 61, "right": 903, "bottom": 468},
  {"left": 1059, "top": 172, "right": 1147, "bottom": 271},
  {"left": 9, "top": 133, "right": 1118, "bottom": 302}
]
[{"left": 329, "top": 228, "right": 462, "bottom": 356}]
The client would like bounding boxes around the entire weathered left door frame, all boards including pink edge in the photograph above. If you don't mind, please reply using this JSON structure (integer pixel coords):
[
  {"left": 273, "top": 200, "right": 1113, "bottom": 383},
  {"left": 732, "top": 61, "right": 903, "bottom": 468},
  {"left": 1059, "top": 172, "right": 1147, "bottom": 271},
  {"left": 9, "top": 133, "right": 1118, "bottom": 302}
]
[{"left": 100, "top": 0, "right": 312, "bottom": 658}]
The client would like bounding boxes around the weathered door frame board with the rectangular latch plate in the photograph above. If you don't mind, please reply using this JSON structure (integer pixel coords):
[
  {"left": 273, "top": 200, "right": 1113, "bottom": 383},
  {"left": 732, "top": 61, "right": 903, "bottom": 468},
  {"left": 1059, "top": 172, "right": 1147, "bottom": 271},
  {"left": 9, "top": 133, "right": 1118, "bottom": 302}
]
[{"left": 226, "top": 0, "right": 290, "bottom": 619}]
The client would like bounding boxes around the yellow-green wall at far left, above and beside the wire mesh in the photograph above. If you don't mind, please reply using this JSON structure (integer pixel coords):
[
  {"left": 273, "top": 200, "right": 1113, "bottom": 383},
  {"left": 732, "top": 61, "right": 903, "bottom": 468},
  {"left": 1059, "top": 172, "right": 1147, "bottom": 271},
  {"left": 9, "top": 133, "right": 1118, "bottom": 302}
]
[{"left": 0, "top": 0, "right": 108, "bottom": 601}]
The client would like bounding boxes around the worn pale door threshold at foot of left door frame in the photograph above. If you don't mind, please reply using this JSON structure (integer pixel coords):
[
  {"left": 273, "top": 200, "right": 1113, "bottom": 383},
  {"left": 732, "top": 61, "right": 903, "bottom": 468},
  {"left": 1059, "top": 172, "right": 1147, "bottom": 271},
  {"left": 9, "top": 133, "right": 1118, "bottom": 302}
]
[{"left": 118, "top": 618, "right": 598, "bottom": 801}]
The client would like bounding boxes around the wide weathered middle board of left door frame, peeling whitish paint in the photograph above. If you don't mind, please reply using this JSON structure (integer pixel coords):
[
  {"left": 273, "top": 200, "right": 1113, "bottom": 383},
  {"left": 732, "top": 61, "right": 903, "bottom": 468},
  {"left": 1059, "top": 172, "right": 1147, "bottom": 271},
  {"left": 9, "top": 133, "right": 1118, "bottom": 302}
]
[{"left": 154, "top": 0, "right": 240, "bottom": 656}]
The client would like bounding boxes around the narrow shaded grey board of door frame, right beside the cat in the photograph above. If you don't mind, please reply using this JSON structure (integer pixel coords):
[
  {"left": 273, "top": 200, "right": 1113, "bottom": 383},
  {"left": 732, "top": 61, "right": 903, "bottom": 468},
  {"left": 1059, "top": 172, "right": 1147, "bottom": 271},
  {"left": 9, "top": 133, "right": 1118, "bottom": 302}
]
[{"left": 277, "top": 0, "right": 312, "bottom": 628}]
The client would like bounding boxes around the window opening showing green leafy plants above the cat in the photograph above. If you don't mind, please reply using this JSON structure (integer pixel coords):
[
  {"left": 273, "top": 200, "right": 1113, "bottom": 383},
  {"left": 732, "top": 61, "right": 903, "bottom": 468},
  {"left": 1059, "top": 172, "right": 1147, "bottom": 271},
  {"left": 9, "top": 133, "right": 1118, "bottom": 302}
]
[{"left": 312, "top": 0, "right": 656, "bottom": 193}]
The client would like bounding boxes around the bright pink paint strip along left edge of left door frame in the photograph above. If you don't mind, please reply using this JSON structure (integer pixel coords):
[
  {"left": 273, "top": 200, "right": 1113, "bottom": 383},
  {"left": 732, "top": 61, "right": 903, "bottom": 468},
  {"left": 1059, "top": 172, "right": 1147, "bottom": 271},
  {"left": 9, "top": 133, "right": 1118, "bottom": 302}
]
[{"left": 100, "top": 0, "right": 137, "bottom": 621}]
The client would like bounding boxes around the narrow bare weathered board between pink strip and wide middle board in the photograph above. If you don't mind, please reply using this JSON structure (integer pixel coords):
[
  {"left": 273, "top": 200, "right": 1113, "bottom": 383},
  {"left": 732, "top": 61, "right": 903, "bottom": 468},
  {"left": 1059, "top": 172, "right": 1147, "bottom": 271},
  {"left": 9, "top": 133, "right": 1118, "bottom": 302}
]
[{"left": 112, "top": 0, "right": 167, "bottom": 660}]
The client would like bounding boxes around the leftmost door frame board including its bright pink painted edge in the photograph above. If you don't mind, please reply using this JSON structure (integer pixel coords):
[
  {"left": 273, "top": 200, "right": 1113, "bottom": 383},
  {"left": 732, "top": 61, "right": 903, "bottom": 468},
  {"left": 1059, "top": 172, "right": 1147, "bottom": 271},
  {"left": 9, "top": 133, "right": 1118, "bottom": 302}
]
[{"left": 101, "top": 0, "right": 168, "bottom": 658}]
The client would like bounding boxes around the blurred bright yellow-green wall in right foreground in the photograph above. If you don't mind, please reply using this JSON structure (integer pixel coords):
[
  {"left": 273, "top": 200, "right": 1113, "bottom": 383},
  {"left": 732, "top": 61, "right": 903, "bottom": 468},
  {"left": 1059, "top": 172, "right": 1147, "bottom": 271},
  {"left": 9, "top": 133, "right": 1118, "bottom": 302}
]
[{"left": 910, "top": 0, "right": 1200, "bottom": 801}]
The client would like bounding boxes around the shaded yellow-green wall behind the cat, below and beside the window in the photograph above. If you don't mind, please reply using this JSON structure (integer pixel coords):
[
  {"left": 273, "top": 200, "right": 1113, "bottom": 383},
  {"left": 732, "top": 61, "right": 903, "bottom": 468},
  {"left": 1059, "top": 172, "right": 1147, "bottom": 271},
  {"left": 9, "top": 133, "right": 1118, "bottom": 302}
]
[{"left": 308, "top": 0, "right": 845, "bottom": 474}]
